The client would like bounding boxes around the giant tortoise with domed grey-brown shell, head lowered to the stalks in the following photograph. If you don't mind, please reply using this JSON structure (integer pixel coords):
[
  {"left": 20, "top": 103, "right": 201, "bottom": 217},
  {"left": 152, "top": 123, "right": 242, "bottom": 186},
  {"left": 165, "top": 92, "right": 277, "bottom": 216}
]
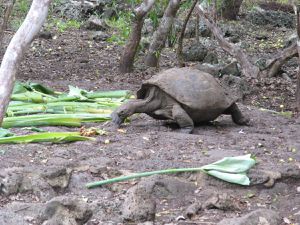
[{"left": 111, "top": 68, "right": 249, "bottom": 133}]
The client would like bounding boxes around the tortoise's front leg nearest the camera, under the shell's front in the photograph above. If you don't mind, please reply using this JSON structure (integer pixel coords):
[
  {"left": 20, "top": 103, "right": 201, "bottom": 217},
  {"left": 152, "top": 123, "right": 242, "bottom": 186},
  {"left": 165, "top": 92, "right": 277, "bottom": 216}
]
[{"left": 172, "top": 104, "right": 194, "bottom": 134}]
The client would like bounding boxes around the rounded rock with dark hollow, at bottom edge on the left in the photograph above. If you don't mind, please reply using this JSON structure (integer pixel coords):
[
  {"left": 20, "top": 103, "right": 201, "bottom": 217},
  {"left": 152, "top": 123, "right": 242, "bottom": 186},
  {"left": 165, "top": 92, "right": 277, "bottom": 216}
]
[{"left": 42, "top": 196, "right": 93, "bottom": 225}]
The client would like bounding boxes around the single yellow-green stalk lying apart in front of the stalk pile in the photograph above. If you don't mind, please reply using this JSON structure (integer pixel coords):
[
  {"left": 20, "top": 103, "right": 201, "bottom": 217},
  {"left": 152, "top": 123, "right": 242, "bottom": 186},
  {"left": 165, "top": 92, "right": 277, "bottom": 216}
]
[{"left": 0, "top": 132, "right": 95, "bottom": 144}]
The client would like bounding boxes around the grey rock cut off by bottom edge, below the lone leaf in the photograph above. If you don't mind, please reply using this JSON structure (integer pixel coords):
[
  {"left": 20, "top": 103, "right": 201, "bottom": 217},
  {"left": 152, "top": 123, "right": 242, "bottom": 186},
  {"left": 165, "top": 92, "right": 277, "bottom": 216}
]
[{"left": 217, "top": 209, "right": 281, "bottom": 225}]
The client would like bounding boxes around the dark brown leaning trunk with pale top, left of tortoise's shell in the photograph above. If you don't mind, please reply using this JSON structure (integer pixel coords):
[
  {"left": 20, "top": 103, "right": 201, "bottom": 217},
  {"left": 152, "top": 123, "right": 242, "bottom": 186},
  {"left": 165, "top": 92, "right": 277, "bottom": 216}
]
[{"left": 119, "top": 0, "right": 155, "bottom": 73}]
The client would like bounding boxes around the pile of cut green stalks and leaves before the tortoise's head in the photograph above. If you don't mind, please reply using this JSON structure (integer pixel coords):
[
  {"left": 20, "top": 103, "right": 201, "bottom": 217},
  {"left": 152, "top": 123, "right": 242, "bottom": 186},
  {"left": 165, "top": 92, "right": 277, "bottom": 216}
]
[{"left": 2, "top": 83, "right": 131, "bottom": 128}]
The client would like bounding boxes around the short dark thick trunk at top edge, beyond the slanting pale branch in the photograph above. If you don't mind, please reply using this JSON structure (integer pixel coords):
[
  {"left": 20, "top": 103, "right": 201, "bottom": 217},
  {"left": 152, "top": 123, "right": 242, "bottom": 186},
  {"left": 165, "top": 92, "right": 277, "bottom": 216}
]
[{"left": 220, "top": 0, "right": 243, "bottom": 20}]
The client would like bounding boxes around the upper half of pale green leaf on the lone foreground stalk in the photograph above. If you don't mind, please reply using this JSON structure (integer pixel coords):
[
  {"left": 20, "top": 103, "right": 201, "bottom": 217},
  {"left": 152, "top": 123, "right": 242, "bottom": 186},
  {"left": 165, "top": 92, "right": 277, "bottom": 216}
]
[{"left": 201, "top": 154, "right": 255, "bottom": 173}]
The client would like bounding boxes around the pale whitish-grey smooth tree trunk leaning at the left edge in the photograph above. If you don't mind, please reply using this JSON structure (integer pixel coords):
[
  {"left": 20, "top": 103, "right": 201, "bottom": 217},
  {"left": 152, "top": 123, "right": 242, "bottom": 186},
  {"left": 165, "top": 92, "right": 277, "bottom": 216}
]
[{"left": 0, "top": 0, "right": 51, "bottom": 126}]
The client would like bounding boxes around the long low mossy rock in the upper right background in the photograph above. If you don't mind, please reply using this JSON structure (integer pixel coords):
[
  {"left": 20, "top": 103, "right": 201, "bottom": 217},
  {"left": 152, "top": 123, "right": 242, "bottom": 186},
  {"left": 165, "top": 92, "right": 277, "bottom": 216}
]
[{"left": 247, "top": 7, "right": 295, "bottom": 28}]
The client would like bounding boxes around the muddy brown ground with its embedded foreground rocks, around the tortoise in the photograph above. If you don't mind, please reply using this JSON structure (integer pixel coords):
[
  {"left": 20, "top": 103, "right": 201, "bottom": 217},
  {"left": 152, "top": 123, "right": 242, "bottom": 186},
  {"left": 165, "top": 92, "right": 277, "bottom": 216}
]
[{"left": 0, "top": 19, "right": 300, "bottom": 225}]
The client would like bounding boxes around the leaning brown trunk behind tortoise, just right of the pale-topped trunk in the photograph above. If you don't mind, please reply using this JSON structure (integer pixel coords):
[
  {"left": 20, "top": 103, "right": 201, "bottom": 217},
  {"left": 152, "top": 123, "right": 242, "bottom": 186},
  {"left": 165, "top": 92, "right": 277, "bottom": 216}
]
[{"left": 146, "top": 0, "right": 180, "bottom": 67}]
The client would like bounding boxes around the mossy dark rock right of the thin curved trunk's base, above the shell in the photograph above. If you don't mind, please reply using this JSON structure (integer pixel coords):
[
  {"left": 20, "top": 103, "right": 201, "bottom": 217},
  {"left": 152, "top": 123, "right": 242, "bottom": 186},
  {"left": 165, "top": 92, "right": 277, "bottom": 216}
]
[{"left": 182, "top": 42, "right": 207, "bottom": 61}]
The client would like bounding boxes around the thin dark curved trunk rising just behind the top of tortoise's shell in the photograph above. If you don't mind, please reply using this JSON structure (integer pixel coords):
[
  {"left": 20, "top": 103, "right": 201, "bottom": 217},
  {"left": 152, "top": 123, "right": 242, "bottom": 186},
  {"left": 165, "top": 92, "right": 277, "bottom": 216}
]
[{"left": 176, "top": 0, "right": 199, "bottom": 67}]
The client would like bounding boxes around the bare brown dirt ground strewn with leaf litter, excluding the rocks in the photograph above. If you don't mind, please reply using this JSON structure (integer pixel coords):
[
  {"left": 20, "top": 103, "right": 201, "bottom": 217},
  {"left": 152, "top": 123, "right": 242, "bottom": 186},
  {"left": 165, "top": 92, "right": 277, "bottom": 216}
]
[{"left": 0, "top": 21, "right": 300, "bottom": 225}]
